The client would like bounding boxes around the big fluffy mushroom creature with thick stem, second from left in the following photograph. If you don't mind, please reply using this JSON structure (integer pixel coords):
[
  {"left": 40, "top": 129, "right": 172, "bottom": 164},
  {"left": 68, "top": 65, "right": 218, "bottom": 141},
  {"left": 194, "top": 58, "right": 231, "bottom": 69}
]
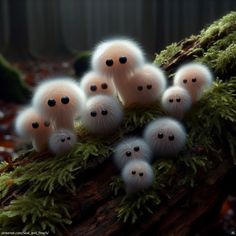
[{"left": 32, "top": 78, "right": 85, "bottom": 130}]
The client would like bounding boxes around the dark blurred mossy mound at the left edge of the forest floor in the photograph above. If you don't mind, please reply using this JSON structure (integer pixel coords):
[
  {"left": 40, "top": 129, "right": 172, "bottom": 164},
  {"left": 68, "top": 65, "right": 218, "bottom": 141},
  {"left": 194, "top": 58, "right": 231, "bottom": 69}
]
[{"left": 0, "top": 55, "right": 31, "bottom": 103}]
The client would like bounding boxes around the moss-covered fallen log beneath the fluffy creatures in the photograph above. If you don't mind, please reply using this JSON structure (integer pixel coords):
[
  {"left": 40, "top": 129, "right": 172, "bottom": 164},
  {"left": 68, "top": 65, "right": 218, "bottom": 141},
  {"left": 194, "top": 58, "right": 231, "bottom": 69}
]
[{"left": 0, "top": 13, "right": 236, "bottom": 236}]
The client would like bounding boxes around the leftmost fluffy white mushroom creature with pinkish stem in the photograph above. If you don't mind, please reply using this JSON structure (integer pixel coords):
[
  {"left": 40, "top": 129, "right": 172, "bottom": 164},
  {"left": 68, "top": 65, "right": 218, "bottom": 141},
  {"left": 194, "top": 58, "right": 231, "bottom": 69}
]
[{"left": 15, "top": 107, "right": 53, "bottom": 152}]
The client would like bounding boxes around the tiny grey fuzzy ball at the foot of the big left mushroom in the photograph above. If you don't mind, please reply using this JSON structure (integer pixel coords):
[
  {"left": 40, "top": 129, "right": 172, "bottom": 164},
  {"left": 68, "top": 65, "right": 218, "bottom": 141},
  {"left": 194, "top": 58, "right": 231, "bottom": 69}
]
[{"left": 49, "top": 129, "right": 77, "bottom": 155}]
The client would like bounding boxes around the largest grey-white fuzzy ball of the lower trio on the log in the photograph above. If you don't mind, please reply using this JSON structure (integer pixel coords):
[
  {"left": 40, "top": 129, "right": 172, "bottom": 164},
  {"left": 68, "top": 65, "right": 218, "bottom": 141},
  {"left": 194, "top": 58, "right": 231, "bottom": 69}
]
[{"left": 144, "top": 117, "right": 187, "bottom": 156}]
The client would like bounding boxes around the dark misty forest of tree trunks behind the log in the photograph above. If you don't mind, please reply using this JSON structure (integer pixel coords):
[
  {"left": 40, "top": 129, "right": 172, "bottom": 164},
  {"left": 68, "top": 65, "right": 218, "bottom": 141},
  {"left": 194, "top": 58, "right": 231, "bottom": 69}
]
[{"left": 0, "top": 0, "right": 236, "bottom": 59}]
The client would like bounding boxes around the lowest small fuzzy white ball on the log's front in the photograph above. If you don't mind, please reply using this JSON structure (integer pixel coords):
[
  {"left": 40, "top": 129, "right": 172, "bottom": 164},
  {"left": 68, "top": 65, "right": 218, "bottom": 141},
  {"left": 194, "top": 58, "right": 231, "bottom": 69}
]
[{"left": 121, "top": 160, "right": 154, "bottom": 193}]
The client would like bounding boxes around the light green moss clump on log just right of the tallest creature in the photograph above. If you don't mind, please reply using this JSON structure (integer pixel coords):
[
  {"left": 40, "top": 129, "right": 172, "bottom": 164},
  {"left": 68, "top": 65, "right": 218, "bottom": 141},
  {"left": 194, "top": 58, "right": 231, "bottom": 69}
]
[{"left": 154, "top": 43, "right": 181, "bottom": 65}]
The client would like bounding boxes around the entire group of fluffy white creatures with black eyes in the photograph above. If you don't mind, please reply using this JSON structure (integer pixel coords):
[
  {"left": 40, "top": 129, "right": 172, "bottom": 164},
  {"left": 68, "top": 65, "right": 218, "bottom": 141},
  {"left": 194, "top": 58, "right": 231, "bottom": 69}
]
[{"left": 15, "top": 39, "right": 212, "bottom": 193}]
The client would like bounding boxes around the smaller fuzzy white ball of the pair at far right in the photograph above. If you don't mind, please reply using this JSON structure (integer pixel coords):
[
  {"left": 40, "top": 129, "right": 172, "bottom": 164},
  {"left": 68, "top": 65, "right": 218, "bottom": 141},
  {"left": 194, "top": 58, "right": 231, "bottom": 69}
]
[{"left": 161, "top": 86, "right": 192, "bottom": 119}]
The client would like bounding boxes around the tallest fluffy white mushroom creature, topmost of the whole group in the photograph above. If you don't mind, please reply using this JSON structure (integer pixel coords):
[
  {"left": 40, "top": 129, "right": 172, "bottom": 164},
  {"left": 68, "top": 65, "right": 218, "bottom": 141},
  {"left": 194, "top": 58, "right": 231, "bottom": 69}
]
[{"left": 91, "top": 39, "right": 145, "bottom": 106}]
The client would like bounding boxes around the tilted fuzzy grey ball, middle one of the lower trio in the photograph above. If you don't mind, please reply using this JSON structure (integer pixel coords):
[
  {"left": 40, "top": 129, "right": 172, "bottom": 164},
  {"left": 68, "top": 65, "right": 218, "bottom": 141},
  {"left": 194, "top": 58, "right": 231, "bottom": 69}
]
[{"left": 114, "top": 137, "right": 152, "bottom": 169}]
